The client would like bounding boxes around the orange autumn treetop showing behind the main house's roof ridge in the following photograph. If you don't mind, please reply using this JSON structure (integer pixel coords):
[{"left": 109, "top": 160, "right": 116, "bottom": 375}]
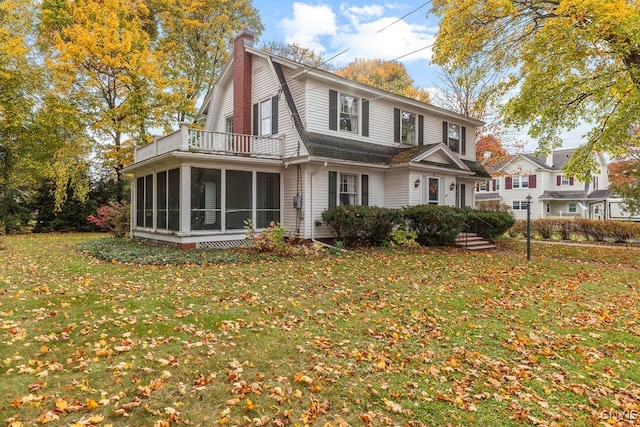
[{"left": 336, "top": 59, "right": 430, "bottom": 102}]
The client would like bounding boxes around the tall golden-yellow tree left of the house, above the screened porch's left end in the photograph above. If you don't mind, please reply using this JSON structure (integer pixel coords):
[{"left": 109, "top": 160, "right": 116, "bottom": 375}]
[{"left": 42, "top": 0, "right": 171, "bottom": 192}]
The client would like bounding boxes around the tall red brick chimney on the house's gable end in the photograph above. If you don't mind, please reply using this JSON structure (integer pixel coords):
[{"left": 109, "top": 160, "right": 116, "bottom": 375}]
[{"left": 233, "top": 28, "right": 254, "bottom": 135}]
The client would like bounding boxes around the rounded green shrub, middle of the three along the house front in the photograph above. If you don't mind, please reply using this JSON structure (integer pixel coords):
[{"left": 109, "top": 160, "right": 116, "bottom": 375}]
[{"left": 402, "top": 205, "right": 465, "bottom": 246}]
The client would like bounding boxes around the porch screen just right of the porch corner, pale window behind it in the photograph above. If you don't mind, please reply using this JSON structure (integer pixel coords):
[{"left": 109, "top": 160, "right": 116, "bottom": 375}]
[{"left": 189, "top": 168, "right": 222, "bottom": 230}]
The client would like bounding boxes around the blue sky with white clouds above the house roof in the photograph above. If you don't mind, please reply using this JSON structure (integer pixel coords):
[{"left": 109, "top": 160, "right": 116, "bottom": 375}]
[{"left": 253, "top": 0, "right": 588, "bottom": 151}]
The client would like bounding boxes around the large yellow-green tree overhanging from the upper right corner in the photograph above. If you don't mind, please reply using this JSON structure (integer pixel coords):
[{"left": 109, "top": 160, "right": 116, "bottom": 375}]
[{"left": 432, "top": 0, "right": 640, "bottom": 180}]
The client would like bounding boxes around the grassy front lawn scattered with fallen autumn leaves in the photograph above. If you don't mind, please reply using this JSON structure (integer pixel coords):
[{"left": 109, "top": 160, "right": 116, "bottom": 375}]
[{"left": 0, "top": 235, "right": 640, "bottom": 426}]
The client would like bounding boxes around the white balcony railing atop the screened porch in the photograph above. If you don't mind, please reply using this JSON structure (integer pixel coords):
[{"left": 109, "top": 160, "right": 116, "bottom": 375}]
[{"left": 135, "top": 125, "right": 283, "bottom": 163}]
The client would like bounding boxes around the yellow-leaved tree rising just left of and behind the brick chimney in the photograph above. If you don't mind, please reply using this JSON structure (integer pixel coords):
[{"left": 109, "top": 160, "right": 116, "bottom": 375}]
[{"left": 149, "top": 0, "right": 263, "bottom": 122}]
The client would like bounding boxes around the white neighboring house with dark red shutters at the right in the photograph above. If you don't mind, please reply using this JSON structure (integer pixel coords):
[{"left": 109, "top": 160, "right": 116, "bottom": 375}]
[{"left": 475, "top": 149, "right": 640, "bottom": 221}]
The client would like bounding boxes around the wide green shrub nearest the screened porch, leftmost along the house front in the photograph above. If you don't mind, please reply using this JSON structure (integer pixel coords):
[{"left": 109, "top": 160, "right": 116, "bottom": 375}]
[{"left": 322, "top": 206, "right": 400, "bottom": 247}]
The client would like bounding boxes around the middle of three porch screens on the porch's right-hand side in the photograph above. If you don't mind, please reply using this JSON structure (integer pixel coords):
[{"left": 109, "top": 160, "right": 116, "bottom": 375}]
[{"left": 225, "top": 170, "right": 253, "bottom": 230}]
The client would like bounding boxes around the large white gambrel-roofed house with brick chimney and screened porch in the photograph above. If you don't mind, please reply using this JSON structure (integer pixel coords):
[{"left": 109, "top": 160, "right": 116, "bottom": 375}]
[{"left": 125, "top": 31, "right": 490, "bottom": 247}]
